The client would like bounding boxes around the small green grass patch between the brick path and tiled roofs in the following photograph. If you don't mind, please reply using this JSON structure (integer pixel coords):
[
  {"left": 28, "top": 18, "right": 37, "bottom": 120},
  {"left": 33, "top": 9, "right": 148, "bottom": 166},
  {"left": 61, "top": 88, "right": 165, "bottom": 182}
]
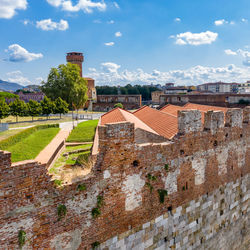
[{"left": 67, "top": 120, "right": 98, "bottom": 142}]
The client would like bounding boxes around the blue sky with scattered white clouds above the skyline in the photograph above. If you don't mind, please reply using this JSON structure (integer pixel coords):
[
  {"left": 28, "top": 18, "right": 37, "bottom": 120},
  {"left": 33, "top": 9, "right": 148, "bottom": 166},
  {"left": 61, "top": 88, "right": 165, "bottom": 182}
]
[{"left": 0, "top": 0, "right": 250, "bottom": 85}]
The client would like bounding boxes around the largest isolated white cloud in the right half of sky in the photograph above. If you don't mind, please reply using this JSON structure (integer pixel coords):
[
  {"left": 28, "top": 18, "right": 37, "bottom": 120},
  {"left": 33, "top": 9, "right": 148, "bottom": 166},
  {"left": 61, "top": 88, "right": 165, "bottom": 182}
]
[{"left": 171, "top": 31, "right": 218, "bottom": 46}]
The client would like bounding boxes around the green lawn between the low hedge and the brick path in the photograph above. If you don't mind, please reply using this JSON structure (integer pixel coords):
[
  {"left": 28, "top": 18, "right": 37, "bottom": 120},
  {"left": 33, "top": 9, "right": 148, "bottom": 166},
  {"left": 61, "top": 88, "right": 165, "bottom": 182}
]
[{"left": 4, "top": 128, "right": 60, "bottom": 162}]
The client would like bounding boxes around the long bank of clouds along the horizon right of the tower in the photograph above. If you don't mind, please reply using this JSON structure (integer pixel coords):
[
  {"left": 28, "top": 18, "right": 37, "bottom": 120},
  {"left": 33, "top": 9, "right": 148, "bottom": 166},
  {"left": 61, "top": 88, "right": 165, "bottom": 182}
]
[{"left": 89, "top": 62, "right": 250, "bottom": 85}]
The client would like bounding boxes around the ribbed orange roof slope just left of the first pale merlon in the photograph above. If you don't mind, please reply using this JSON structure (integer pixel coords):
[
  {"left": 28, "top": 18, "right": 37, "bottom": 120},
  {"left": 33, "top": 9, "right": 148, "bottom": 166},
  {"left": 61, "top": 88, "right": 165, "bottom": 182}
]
[{"left": 133, "top": 106, "right": 178, "bottom": 139}]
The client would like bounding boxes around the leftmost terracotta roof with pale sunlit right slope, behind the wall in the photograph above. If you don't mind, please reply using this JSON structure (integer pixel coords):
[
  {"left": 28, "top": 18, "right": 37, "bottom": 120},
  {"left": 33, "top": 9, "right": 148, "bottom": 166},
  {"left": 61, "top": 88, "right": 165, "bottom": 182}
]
[{"left": 100, "top": 108, "right": 158, "bottom": 135}]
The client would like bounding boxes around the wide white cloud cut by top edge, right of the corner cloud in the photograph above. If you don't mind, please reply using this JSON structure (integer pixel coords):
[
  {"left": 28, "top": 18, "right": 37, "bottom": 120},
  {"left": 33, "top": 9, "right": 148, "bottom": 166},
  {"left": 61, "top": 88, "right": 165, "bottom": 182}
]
[{"left": 47, "top": 0, "right": 107, "bottom": 13}]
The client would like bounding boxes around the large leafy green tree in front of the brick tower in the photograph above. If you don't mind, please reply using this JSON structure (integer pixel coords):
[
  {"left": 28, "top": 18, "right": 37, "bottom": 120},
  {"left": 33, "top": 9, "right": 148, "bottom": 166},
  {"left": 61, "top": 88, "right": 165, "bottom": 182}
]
[{"left": 42, "top": 63, "right": 88, "bottom": 107}]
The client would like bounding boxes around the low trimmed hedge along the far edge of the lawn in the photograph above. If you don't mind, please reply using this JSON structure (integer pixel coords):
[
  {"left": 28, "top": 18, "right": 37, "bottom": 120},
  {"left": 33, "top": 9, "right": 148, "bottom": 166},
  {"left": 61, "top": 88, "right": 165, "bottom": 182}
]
[{"left": 0, "top": 124, "right": 59, "bottom": 150}]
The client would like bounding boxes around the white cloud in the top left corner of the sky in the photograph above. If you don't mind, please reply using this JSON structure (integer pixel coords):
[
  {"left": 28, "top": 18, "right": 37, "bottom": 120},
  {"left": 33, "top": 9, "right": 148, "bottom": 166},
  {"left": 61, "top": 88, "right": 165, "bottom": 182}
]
[{"left": 0, "top": 0, "right": 28, "bottom": 19}]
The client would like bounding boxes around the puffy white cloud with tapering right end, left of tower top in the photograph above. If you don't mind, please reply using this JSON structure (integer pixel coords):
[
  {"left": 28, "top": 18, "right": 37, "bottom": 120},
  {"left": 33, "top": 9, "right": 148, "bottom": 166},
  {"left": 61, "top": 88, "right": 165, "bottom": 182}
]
[{"left": 6, "top": 44, "right": 43, "bottom": 62}]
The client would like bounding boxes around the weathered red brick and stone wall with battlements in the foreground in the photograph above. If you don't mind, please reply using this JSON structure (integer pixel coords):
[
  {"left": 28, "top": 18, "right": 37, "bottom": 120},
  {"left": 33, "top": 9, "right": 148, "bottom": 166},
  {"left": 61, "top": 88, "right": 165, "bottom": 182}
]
[{"left": 0, "top": 109, "right": 250, "bottom": 249}]
